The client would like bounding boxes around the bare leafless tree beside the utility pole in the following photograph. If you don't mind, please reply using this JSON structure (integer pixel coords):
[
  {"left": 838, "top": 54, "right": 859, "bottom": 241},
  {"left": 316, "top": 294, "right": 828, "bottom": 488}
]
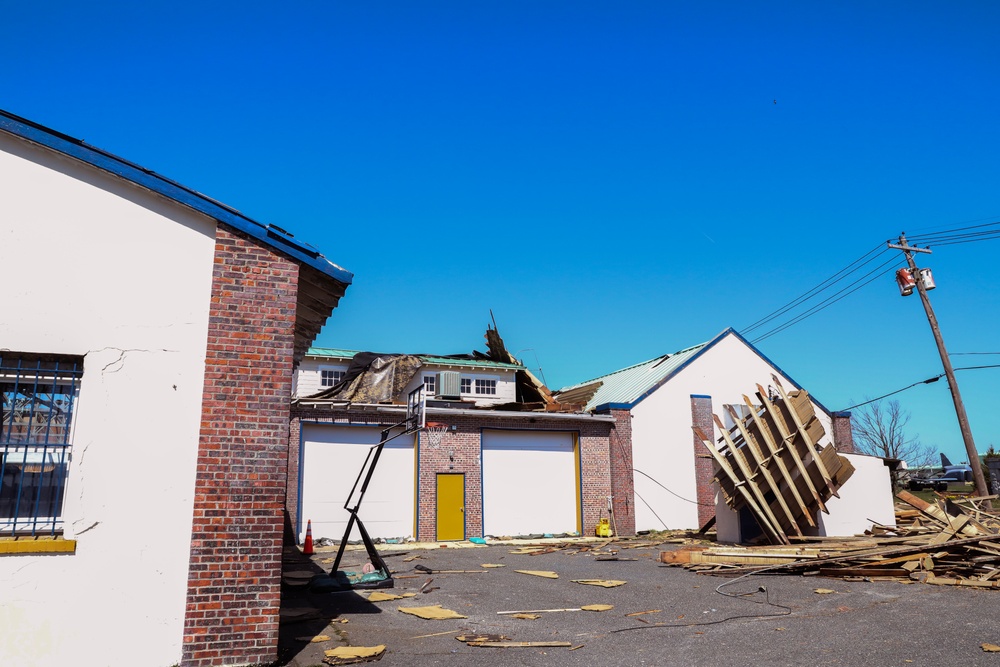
[{"left": 851, "top": 400, "right": 937, "bottom": 468}]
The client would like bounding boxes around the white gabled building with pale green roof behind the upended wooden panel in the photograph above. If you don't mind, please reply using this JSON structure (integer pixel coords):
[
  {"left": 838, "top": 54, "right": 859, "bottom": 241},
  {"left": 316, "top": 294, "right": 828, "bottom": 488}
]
[{"left": 556, "top": 329, "right": 853, "bottom": 530}]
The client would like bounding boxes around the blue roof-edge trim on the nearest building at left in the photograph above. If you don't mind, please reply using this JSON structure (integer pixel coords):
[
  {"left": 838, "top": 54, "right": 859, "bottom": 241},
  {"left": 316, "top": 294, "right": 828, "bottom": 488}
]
[{"left": 0, "top": 110, "right": 354, "bottom": 285}]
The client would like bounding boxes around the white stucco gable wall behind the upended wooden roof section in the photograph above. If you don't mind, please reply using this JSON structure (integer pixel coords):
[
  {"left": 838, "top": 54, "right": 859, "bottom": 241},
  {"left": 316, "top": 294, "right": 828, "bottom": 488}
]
[{"left": 632, "top": 335, "right": 833, "bottom": 530}]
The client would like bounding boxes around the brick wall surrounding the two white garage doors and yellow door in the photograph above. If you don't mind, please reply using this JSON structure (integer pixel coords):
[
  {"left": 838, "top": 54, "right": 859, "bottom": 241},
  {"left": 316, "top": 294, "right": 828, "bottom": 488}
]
[{"left": 287, "top": 407, "right": 612, "bottom": 541}]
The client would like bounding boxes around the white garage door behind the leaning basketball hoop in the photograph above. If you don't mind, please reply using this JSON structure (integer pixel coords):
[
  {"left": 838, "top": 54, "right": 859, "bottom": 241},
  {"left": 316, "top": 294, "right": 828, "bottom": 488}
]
[{"left": 299, "top": 424, "right": 415, "bottom": 542}]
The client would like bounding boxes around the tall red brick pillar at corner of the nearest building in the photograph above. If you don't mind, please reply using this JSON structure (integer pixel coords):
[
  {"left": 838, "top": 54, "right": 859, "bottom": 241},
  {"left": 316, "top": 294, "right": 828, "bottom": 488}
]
[{"left": 181, "top": 225, "right": 298, "bottom": 667}]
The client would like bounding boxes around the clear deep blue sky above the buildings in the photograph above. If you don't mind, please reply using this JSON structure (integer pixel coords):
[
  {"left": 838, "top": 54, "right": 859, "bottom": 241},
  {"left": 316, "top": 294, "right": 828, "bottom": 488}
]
[{"left": 0, "top": 1, "right": 1000, "bottom": 468}]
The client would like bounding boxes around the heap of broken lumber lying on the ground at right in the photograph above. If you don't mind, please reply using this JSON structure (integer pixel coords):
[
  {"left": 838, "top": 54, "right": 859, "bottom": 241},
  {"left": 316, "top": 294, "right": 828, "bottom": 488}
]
[{"left": 660, "top": 491, "right": 1000, "bottom": 588}]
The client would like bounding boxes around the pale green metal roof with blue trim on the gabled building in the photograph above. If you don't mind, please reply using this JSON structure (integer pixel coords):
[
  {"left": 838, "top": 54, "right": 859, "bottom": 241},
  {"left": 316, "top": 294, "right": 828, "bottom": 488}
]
[{"left": 555, "top": 327, "right": 830, "bottom": 413}]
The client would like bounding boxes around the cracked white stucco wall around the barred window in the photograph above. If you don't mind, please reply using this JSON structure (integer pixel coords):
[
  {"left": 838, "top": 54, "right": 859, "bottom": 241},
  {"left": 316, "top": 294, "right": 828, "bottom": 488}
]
[{"left": 0, "top": 133, "right": 215, "bottom": 667}]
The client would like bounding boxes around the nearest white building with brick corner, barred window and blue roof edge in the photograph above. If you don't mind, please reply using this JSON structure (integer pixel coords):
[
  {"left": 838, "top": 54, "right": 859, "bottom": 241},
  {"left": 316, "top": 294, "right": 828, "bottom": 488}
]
[{"left": 0, "top": 112, "right": 351, "bottom": 667}]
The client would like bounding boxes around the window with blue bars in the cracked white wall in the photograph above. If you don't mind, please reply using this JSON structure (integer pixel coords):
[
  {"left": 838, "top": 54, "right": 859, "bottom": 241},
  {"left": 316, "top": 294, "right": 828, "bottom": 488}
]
[{"left": 0, "top": 352, "right": 83, "bottom": 535}]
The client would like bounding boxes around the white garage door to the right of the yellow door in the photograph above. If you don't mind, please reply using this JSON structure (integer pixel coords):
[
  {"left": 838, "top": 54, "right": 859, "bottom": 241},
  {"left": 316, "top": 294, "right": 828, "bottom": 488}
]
[{"left": 483, "top": 431, "right": 580, "bottom": 536}]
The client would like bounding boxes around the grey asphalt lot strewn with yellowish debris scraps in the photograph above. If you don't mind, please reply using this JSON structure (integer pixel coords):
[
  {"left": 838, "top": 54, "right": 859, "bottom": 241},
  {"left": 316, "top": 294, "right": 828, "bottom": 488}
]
[{"left": 281, "top": 542, "right": 1000, "bottom": 667}]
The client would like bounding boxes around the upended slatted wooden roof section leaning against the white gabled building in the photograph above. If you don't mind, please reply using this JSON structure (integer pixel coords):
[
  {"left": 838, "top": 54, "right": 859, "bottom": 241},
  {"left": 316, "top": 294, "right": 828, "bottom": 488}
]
[{"left": 695, "top": 377, "right": 854, "bottom": 544}]
